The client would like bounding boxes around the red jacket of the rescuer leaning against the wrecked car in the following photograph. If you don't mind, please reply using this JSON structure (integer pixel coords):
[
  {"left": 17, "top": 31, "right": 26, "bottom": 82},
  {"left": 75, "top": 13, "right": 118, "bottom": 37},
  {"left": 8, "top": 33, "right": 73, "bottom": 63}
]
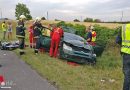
[{"left": 51, "top": 27, "right": 63, "bottom": 39}]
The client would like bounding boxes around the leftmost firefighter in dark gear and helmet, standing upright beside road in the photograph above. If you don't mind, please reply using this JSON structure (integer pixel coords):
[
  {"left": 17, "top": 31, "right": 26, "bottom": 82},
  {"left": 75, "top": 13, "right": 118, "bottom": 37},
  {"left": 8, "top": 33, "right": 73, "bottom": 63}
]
[{"left": 16, "top": 15, "right": 26, "bottom": 55}]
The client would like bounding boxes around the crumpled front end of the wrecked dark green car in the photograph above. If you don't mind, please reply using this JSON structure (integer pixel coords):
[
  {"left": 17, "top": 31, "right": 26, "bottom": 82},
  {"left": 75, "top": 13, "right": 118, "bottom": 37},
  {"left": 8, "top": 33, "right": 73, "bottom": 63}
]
[{"left": 60, "top": 42, "right": 96, "bottom": 64}]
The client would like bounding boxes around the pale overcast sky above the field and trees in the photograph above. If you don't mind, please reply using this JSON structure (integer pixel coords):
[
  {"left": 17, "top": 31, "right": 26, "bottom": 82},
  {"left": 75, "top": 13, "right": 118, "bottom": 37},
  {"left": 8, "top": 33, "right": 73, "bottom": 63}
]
[{"left": 0, "top": 0, "right": 130, "bottom": 21}]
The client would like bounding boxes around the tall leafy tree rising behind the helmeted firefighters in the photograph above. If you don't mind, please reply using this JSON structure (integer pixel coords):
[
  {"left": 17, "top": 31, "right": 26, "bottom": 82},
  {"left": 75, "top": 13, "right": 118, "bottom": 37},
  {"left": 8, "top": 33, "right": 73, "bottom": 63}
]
[{"left": 15, "top": 3, "right": 32, "bottom": 20}]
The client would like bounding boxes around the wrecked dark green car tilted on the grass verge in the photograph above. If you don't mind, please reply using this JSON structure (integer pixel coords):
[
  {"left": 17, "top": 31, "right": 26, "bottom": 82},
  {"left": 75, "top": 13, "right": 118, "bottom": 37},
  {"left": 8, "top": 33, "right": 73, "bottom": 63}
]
[{"left": 40, "top": 27, "right": 96, "bottom": 64}]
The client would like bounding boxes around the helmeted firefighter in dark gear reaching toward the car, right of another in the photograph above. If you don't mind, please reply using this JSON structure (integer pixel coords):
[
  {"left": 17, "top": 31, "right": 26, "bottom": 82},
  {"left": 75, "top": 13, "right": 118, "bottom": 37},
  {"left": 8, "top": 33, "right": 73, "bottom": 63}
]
[{"left": 33, "top": 17, "right": 46, "bottom": 54}]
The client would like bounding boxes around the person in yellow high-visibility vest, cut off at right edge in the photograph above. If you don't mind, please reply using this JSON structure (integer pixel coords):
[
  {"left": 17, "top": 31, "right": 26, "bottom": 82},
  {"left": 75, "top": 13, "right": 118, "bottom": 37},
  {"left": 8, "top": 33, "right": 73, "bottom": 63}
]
[{"left": 116, "top": 24, "right": 130, "bottom": 90}]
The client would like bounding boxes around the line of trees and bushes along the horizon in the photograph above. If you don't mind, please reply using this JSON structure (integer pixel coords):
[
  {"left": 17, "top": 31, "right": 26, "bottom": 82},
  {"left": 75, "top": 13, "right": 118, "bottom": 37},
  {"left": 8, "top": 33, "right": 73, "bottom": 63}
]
[{"left": 15, "top": 3, "right": 130, "bottom": 23}]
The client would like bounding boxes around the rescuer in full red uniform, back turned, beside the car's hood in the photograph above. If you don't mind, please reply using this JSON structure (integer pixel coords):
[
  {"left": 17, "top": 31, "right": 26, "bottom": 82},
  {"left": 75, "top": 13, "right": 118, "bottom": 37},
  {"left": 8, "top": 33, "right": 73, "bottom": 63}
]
[{"left": 50, "top": 26, "right": 64, "bottom": 57}]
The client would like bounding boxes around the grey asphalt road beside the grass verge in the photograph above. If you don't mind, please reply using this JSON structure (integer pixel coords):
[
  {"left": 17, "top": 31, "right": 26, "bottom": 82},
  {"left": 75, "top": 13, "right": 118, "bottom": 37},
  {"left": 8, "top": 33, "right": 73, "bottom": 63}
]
[{"left": 0, "top": 50, "right": 57, "bottom": 90}]
